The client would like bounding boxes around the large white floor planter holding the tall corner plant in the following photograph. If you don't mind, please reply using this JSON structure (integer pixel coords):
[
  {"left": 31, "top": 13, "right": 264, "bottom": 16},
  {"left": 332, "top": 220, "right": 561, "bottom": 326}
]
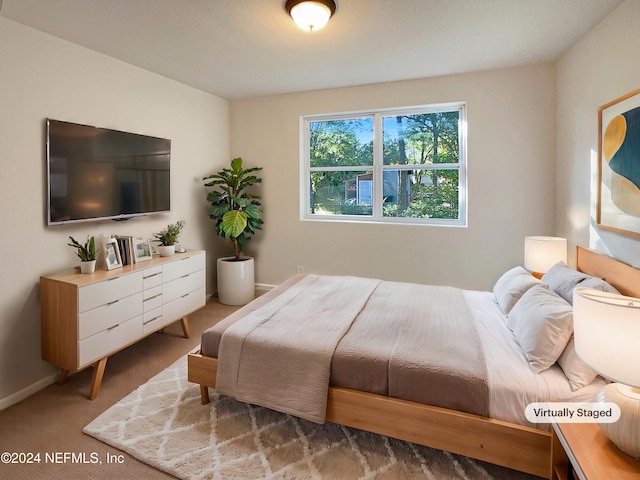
[{"left": 217, "top": 257, "right": 256, "bottom": 305}]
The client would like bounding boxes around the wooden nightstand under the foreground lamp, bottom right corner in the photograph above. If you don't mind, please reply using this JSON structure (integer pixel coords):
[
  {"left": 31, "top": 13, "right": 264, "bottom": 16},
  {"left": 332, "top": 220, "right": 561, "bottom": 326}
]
[{"left": 551, "top": 423, "right": 640, "bottom": 480}]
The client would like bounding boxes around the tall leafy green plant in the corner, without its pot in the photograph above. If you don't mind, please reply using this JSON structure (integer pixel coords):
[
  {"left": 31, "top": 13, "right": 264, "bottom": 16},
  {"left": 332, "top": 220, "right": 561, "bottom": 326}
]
[{"left": 203, "top": 157, "right": 263, "bottom": 260}]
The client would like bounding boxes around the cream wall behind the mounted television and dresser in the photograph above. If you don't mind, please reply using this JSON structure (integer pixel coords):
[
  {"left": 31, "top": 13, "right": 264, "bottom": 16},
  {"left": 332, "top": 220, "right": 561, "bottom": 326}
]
[{"left": 0, "top": 17, "right": 229, "bottom": 406}]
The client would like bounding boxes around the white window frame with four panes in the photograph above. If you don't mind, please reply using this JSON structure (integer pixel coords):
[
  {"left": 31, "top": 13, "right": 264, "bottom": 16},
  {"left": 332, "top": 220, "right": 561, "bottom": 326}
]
[{"left": 300, "top": 102, "right": 468, "bottom": 227}]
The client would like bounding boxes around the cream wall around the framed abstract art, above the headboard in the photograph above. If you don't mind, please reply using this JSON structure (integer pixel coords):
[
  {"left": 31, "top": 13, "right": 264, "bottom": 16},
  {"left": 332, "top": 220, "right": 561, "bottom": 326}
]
[{"left": 556, "top": 0, "right": 640, "bottom": 267}]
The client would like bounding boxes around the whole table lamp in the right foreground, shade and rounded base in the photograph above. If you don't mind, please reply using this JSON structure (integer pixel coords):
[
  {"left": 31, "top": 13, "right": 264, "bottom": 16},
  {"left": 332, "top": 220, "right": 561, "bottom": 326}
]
[{"left": 573, "top": 287, "right": 640, "bottom": 458}]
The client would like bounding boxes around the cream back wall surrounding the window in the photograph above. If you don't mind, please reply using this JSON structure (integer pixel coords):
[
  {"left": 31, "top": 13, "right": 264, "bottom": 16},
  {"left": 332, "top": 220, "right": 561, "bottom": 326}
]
[{"left": 231, "top": 64, "right": 556, "bottom": 289}]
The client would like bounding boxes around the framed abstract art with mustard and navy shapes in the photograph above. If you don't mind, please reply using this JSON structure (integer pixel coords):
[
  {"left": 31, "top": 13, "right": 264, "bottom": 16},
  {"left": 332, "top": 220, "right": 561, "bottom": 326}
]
[{"left": 596, "top": 89, "right": 640, "bottom": 237}]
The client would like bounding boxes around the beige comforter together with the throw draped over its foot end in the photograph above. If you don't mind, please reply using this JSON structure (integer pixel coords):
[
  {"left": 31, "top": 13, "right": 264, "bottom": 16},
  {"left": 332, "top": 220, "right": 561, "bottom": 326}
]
[{"left": 216, "top": 275, "right": 489, "bottom": 423}]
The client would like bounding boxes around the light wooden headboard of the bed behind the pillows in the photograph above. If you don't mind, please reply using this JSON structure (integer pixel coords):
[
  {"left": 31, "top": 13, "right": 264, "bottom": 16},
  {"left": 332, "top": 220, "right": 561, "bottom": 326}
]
[{"left": 576, "top": 247, "right": 640, "bottom": 297}]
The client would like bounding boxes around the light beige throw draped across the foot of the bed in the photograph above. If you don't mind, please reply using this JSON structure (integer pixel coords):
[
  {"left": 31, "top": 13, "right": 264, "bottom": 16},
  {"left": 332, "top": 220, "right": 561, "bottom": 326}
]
[{"left": 216, "top": 275, "right": 380, "bottom": 423}]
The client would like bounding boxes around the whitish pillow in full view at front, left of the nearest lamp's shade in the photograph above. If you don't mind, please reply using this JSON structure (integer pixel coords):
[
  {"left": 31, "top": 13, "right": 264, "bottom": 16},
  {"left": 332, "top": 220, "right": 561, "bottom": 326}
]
[{"left": 507, "top": 285, "right": 573, "bottom": 373}]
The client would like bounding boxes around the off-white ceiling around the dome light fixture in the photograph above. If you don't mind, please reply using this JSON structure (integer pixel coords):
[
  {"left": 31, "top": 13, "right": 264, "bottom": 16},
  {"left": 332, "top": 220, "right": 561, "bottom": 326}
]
[{"left": 0, "top": 0, "right": 622, "bottom": 99}]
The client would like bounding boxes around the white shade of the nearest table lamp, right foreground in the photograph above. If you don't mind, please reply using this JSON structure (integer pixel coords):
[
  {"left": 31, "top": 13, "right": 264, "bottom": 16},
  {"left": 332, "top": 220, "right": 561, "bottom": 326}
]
[{"left": 573, "top": 287, "right": 640, "bottom": 388}]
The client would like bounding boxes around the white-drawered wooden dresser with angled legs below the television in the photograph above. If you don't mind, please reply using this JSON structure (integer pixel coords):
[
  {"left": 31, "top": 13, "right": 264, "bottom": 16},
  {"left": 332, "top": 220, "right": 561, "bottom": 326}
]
[{"left": 40, "top": 250, "right": 206, "bottom": 400}]
